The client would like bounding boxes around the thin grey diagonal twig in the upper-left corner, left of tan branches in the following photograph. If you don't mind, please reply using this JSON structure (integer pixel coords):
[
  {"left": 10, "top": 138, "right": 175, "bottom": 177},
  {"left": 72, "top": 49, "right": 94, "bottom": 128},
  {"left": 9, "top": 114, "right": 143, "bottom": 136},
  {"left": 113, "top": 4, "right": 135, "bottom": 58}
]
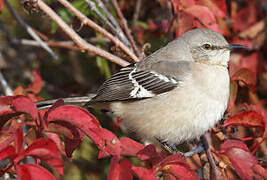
[{"left": 4, "top": 0, "right": 58, "bottom": 59}]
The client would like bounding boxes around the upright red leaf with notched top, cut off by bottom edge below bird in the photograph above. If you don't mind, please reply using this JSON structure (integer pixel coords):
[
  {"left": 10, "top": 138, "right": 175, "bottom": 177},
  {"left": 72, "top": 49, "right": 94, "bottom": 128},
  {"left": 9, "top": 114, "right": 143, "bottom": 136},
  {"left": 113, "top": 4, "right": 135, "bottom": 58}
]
[{"left": 107, "top": 156, "right": 133, "bottom": 180}]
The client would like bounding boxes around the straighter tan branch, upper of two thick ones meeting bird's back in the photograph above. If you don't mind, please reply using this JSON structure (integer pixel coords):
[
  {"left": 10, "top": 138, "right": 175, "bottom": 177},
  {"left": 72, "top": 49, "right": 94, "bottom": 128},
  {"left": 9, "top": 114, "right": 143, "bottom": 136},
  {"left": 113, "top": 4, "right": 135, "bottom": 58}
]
[{"left": 58, "top": 0, "right": 139, "bottom": 62}]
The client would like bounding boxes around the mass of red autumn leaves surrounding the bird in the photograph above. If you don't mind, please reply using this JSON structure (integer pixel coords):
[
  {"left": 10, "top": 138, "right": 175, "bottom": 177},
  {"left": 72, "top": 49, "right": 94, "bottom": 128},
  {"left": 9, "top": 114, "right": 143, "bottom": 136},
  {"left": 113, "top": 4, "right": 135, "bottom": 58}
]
[{"left": 0, "top": 0, "right": 267, "bottom": 180}]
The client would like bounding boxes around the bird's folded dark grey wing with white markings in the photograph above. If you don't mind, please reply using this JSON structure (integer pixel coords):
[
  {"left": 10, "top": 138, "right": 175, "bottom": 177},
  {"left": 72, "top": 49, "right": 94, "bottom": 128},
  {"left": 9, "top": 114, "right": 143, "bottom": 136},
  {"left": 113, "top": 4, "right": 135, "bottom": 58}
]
[{"left": 91, "top": 61, "right": 192, "bottom": 103}]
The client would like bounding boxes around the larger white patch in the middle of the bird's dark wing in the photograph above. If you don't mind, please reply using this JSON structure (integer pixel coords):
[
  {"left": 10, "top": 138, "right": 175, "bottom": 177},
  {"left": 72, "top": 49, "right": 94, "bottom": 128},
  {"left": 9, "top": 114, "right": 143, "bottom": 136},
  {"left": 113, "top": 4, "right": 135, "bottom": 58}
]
[{"left": 129, "top": 68, "right": 155, "bottom": 98}]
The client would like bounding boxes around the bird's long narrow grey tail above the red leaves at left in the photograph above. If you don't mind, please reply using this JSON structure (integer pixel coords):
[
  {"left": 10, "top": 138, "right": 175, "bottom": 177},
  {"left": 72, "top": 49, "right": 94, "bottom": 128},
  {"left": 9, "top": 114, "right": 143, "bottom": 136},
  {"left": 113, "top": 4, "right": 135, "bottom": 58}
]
[{"left": 35, "top": 94, "right": 95, "bottom": 110}]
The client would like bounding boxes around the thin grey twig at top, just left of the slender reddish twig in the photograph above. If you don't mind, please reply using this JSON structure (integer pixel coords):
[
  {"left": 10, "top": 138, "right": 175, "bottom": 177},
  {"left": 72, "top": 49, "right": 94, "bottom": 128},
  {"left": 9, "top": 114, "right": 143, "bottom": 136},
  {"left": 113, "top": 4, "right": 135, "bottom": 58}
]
[{"left": 96, "top": 0, "right": 130, "bottom": 46}]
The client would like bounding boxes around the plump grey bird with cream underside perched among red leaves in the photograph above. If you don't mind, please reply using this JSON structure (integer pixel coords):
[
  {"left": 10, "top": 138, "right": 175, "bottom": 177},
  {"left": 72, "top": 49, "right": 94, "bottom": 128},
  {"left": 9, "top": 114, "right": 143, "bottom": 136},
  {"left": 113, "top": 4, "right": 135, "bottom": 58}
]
[{"left": 36, "top": 29, "right": 244, "bottom": 150}]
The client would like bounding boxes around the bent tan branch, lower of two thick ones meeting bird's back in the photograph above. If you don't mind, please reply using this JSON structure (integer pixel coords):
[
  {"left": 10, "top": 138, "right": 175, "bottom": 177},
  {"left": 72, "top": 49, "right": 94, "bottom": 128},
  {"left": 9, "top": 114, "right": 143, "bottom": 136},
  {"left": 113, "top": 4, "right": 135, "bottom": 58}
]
[{"left": 38, "top": 0, "right": 129, "bottom": 66}]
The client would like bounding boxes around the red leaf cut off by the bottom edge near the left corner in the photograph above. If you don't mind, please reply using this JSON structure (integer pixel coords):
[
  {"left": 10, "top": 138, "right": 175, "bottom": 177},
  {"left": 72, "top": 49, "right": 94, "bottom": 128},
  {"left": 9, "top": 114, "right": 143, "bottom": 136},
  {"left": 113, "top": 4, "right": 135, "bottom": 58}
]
[{"left": 16, "top": 164, "right": 56, "bottom": 180}]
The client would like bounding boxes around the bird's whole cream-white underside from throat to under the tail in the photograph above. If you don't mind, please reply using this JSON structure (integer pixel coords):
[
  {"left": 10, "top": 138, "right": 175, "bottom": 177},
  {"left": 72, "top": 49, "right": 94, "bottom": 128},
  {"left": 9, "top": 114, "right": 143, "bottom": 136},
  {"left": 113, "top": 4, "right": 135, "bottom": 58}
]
[{"left": 110, "top": 65, "right": 229, "bottom": 144}]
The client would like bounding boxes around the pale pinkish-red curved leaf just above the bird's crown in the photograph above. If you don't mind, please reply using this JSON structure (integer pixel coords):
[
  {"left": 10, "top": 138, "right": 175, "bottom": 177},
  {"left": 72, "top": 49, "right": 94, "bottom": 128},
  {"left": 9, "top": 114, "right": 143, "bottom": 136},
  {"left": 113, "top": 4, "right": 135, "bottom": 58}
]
[{"left": 184, "top": 5, "right": 219, "bottom": 32}]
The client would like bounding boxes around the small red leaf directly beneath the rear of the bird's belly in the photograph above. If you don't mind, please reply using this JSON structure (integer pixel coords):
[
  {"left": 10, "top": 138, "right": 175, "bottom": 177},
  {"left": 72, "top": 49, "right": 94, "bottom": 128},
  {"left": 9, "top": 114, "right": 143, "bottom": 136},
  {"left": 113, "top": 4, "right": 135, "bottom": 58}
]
[{"left": 120, "top": 137, "right": 144, "bottom": 156}]
